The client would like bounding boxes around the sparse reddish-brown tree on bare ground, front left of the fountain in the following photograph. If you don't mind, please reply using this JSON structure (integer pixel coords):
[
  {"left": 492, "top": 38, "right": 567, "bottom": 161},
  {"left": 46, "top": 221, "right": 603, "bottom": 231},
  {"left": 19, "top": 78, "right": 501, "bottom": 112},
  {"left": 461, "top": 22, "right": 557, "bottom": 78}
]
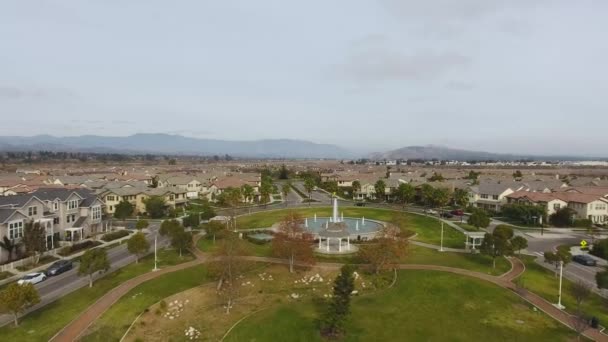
[{"left": 211, "top": 232, "right": 247, "bottom": 314}]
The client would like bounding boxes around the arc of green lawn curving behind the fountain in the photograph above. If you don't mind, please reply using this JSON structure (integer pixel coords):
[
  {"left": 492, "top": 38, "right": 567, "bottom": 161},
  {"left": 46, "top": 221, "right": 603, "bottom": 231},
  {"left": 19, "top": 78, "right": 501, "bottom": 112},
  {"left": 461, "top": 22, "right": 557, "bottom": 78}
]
[{"left": 236, "top": 207, "right": 464, "bottom": 248}]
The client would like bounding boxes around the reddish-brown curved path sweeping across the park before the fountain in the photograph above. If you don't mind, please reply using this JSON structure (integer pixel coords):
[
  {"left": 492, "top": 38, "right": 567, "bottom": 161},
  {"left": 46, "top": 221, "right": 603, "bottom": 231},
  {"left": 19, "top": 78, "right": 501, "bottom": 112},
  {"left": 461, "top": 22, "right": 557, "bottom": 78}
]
[{"left": 50, "top": 251, "right": 608, "bottom": 342}]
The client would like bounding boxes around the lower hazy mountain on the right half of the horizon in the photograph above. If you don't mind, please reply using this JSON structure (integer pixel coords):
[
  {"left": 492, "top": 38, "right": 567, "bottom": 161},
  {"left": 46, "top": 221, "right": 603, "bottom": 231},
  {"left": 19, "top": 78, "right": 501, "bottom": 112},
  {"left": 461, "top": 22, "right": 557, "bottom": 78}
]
[{"left": 368, "top": 145, "right": 606, "bottom": 161}]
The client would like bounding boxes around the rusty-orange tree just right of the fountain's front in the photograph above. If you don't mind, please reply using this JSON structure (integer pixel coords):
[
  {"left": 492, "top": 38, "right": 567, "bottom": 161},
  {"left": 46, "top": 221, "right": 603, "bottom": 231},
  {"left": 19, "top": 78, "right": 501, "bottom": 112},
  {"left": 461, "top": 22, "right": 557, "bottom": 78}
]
[{"left": 359, "top": 225, "right": 408, "bottom": 274}]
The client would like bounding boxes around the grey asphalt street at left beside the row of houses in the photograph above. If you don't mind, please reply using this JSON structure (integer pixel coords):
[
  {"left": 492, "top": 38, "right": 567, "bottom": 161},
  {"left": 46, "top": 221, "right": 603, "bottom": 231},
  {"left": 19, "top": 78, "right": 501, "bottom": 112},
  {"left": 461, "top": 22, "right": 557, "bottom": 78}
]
[{"left": 0, "top": 223, "right": 168, "bottom": 326}]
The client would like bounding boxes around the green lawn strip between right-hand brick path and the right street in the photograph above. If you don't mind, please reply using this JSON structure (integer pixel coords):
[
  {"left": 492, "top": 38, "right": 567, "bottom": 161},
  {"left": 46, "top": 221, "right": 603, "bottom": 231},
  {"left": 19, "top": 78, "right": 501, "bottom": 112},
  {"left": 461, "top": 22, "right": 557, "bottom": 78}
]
[{"left": 521, "top": 257, "right": 608, "bottom": 325}]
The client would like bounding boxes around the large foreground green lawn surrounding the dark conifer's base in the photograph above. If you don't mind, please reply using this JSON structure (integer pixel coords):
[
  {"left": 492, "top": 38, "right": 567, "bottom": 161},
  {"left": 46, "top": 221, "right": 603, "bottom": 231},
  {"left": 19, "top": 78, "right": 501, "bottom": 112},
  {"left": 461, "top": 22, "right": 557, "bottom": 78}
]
[{"left": 226, "top": 271, "right": 574, "bottom": 342}]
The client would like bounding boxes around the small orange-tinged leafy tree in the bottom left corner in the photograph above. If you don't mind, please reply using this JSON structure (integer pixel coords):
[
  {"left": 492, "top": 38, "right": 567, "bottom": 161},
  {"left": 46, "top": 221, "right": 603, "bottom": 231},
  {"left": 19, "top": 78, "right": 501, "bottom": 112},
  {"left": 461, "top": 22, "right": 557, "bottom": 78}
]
[{"left": 0, "top": 283, "right": 40, "bottom": 326}]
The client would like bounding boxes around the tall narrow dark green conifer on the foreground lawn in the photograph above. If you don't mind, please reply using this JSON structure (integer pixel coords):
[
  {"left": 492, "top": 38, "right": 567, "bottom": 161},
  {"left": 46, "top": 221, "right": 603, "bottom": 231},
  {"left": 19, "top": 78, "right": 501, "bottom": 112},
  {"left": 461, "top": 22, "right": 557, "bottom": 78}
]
[{"left": 321, "top": 265, "right": 355, "bottom": 339}]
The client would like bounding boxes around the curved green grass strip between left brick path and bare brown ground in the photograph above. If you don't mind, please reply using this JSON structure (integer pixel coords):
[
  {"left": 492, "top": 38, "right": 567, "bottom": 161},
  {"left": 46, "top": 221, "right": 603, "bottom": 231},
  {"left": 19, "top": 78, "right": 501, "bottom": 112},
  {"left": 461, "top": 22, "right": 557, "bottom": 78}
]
[{"left": 80, "top": 266, "right": 207, "bottom": 342}]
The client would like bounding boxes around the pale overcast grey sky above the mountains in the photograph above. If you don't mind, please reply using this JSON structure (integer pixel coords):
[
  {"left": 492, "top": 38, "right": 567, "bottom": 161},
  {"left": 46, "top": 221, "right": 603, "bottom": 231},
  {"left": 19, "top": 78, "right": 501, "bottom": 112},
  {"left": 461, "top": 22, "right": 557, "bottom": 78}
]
[{"left": 0, "top": 0, "right": 608, "bottom": 157}]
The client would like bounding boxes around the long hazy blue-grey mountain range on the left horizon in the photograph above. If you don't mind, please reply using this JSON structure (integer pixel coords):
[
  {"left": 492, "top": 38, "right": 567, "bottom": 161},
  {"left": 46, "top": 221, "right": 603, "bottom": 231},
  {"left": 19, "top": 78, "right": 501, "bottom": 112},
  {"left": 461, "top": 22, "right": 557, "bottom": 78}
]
[{"left": 0, "top": 134, "right": 354, "bottom": 159}]
